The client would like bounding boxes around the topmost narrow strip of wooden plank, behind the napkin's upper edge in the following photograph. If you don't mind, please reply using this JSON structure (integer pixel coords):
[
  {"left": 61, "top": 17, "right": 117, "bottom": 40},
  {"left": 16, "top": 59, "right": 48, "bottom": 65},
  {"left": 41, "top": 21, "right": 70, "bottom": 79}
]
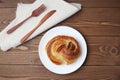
[{"left": 0, "top": 0, "right": 120, "bottom": 8}]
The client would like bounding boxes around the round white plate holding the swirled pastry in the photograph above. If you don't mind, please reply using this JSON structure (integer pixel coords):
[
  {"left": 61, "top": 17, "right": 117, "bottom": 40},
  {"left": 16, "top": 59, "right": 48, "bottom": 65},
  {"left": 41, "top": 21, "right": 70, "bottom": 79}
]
[{"left": 39, "top": 26, "right": 87, "bottom": 74}]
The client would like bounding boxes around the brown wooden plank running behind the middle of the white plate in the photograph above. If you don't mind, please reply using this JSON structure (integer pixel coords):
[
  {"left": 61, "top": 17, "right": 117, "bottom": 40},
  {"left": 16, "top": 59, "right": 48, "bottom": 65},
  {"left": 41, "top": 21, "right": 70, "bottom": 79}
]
[{"left": 0, "top": 36, "right": 120, "bottom": 66}]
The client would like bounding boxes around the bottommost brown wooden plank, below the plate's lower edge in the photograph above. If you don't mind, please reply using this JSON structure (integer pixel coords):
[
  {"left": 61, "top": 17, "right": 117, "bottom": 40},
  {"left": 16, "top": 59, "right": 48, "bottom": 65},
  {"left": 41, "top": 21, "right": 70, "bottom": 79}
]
[{"left": 0, "top": 65, "right": 120, "bottom": 80}]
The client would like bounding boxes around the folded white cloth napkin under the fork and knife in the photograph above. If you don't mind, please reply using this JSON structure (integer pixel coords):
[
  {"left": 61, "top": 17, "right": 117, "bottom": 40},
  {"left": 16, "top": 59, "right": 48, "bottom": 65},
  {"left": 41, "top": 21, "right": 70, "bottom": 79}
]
[{"left": 0, "top": 0, "right": 81, "bottom": 51}]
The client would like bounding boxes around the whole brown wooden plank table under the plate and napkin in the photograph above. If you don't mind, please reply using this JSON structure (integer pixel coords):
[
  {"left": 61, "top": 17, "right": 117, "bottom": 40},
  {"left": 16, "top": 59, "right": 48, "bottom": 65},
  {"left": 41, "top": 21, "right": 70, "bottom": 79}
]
[{"left": 0, "top": 0, "right": 120, "bottom": 80}]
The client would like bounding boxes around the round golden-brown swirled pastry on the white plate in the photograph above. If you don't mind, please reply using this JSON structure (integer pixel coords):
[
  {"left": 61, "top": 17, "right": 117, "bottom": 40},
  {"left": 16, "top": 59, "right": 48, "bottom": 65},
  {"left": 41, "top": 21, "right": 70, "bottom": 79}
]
[{"left": 46, "top": 35, "right": 80, "bottom": 65}]
